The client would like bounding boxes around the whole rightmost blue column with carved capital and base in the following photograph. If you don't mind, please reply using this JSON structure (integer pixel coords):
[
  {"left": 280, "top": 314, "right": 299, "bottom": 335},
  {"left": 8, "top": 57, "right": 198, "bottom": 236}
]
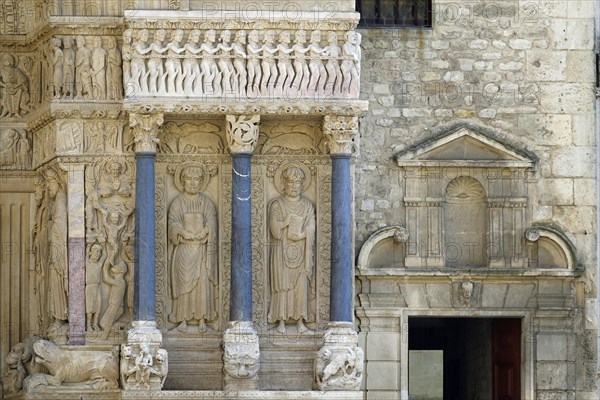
[{"left": 315, "top": 116, "right": 364, "bottom": 390}]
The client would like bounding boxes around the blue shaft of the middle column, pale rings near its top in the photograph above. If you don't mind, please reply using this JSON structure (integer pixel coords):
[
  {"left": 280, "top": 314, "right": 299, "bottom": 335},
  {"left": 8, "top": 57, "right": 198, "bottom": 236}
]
[{"left": 229, "top": 153, "right": 252, "bottom": 321}]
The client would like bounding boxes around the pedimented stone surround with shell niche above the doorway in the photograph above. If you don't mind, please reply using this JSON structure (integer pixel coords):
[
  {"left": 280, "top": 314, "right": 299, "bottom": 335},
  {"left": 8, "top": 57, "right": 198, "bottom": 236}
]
[{"left": 395, "top": 124, "right": 537, "bottom": 269}]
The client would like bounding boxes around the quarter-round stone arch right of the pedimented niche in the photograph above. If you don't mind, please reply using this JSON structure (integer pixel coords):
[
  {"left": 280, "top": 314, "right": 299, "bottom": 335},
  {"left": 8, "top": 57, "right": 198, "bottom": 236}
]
[{"left": 525, "top": 225, "right": 575, "bottom": 270}]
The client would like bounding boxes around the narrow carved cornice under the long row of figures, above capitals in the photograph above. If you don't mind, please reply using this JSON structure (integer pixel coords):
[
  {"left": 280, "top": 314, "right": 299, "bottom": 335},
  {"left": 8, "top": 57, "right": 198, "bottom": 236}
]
[{"left": 123, "top": 97, "right": 369, "bottom": 116}]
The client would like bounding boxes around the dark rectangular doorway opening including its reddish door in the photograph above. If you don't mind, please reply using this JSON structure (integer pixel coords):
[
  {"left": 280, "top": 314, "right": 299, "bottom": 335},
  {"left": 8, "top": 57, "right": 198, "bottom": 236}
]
[{"left": 408, "top": 317, "right": 521, "bottom": 400}]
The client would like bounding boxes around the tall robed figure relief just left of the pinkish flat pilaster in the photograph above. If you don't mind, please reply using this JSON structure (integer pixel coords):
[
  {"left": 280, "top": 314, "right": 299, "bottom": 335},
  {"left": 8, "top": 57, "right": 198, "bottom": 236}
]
[{"left": 46, "top": 170, "right": 69, "bottom": 329}]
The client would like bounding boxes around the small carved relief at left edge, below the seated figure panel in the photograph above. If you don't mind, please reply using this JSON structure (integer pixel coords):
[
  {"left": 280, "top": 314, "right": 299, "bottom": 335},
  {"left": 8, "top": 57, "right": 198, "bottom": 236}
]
[{"left": 0, "top": 128, "right": 33, "bottom": 169}]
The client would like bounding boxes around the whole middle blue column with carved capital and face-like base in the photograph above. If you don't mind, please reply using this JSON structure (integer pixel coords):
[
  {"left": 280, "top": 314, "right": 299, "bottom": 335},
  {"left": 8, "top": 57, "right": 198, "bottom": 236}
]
[{"left": 223, "top": 115, "right": 260, "bottom": 390}]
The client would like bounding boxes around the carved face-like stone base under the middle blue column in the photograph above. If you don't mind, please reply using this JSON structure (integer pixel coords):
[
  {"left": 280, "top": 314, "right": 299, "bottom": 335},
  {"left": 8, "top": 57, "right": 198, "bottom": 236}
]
[{"left": 223, "top": 321, "right": 260, "bottom": 391}]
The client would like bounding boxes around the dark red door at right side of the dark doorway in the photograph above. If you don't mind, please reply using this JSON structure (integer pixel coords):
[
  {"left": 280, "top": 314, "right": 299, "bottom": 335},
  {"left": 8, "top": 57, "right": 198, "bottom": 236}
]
[{"left": 492, "top": 318, "right": 521, "bottom": 400}]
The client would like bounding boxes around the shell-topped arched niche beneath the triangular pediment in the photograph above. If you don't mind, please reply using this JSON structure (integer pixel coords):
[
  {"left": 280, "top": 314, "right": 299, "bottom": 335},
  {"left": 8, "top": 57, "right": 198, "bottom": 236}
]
[{"left": 442, "top": 176, "right": 488, "bottom": 267}]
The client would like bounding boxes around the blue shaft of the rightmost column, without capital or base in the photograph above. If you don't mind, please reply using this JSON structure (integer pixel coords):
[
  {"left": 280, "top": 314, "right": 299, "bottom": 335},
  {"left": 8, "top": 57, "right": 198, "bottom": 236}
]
[{"left": 329, "top": 154, "right": 353, "bottom": 322}]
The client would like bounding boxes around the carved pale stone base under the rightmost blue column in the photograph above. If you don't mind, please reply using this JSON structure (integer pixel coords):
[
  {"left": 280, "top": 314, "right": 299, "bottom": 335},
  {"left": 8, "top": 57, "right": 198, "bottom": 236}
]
[{"left": 315, "top": 322, "right": 364, "bottom": 391}]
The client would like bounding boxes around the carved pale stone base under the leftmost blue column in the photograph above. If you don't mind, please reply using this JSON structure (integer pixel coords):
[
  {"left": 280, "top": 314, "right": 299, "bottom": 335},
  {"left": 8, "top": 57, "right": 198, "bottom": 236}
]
[{"left": 120, "top": 321, "right": 169, "bottom": 390}]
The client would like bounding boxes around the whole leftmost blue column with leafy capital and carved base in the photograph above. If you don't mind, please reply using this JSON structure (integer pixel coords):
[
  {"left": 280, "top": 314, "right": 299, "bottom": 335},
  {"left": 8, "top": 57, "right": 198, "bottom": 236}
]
[{"left": 121, "top": 114, "right": 168, "bottom": 390}]
